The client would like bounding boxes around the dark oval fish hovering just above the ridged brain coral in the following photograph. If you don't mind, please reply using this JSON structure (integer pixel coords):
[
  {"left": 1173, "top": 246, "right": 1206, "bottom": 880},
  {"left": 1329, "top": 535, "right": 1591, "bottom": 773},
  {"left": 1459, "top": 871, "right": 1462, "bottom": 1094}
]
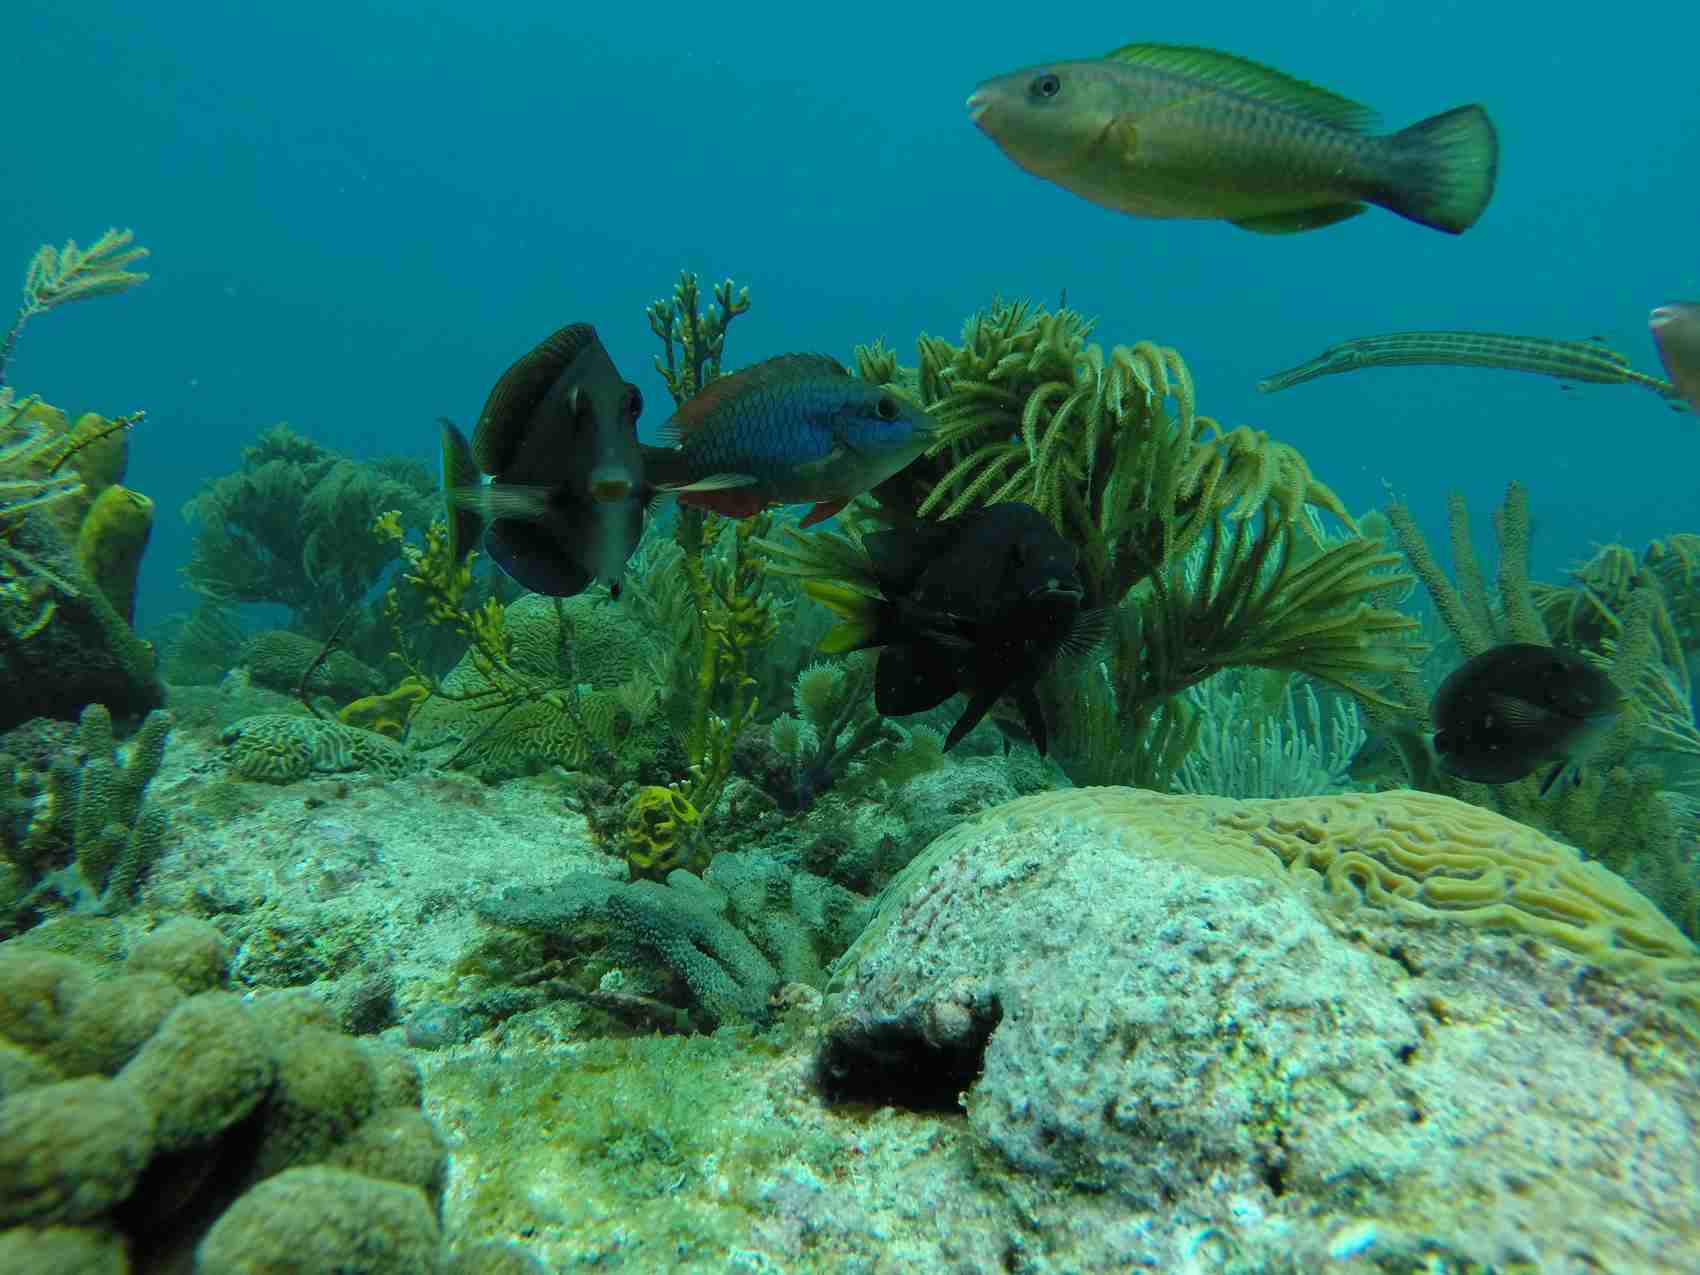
[{"left": 1431, "top": 643, "right": 1624, "bottom": 792}]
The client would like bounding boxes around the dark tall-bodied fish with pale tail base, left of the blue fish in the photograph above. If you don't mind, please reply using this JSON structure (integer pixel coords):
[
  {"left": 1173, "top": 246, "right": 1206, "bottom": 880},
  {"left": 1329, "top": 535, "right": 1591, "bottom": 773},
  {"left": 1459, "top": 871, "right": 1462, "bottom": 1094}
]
[{"left": 442, "top": 323, "right": 649, "bottom": 597}]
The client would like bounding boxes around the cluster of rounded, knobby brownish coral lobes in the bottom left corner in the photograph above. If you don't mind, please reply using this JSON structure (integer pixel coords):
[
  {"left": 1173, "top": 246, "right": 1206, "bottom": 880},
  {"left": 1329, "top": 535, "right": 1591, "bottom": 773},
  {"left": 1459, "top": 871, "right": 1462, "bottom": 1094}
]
[{"left": 0, "top": 921, "right": 444, "bottom": 1275}]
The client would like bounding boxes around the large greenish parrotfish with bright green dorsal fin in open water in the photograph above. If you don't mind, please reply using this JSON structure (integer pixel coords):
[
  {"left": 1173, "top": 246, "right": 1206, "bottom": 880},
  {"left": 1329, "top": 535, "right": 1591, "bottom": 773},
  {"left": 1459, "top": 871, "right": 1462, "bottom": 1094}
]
[{"left": 967, "top": 44, "right": 1499, "bottom": 235}]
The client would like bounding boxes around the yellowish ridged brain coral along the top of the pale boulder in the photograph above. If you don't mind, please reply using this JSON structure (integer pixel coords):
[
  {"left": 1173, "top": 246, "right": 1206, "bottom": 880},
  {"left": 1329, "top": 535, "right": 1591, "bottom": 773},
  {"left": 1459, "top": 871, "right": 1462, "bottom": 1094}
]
[{"left": 840, "top": 787, "right": 1700, "bottom": 1005}]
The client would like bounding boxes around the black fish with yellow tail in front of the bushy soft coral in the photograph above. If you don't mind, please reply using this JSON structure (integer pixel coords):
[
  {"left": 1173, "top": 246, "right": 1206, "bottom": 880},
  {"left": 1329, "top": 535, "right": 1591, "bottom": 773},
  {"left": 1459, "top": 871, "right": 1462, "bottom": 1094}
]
[{"left": 804, "top": 502, "right": 1108, "bottom": 757}]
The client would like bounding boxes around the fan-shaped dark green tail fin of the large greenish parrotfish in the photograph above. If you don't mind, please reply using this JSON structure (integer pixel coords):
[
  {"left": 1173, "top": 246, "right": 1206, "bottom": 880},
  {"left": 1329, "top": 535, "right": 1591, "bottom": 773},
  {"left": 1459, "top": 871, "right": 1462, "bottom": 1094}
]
[{"left": 1375, "top": 105, "right": 1499, "bottom": 235}]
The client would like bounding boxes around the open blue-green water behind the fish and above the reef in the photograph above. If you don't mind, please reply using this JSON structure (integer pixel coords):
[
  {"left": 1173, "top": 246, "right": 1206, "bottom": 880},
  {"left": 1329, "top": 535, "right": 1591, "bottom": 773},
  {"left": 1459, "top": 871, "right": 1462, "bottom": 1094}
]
[{"left": 0, "top": 0, "right": 1700, "bottom": 629}]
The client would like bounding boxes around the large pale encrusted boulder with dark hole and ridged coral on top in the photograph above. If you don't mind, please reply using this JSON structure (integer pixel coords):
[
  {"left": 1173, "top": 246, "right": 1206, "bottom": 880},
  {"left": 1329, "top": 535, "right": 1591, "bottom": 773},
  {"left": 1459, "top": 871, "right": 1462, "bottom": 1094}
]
[{"left": 816, "top": 789, "right": 1700, "bottom": 1272}]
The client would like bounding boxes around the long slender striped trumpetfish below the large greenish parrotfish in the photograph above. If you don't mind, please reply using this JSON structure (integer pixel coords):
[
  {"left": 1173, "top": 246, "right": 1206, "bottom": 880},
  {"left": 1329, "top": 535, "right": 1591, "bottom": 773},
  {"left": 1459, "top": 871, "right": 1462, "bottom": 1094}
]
[{"left": 1258, "top": 332, "right": 1676, "bottom": 400}]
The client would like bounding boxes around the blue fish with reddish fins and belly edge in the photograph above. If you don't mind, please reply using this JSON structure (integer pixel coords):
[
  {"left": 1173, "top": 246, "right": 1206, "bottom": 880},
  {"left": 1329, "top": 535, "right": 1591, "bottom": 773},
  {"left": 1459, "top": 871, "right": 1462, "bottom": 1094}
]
[{"left": 643, "top": 354, "right": 935, "bottom": 527}]
